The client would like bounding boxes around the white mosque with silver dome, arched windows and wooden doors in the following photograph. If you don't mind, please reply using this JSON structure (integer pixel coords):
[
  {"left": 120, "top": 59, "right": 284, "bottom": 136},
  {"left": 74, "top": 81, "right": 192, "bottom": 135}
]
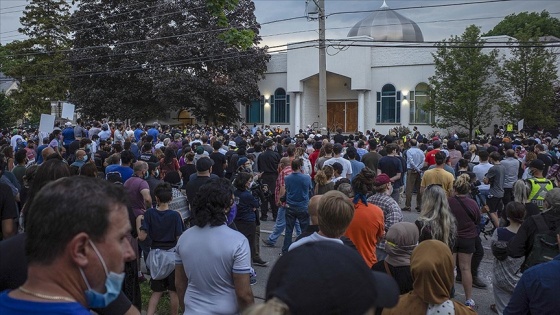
[{"left": 240, "top": 2, "right": 509, "bottom": 133}]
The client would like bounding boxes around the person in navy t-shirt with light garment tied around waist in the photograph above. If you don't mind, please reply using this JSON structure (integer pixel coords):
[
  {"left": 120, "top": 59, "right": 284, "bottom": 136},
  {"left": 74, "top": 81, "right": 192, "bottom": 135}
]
[{"left": 136, "top": 183, "right": 183, "bottom": 315}]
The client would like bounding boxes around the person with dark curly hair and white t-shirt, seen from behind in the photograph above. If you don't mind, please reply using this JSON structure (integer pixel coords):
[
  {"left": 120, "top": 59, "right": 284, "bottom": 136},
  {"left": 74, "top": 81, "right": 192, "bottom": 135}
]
[{"left": 175, "top": 178, "right": 254, "bottom": 314}]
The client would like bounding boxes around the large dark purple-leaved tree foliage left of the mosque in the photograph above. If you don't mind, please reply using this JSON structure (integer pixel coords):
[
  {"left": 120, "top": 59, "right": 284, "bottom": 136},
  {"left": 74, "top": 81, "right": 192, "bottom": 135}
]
[{"left": 71, "top": 0, "right": 268, "bottom": 122}]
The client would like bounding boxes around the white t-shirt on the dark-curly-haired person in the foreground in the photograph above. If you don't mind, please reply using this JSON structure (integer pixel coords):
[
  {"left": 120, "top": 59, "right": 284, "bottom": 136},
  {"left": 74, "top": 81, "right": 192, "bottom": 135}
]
[{"left": 175, "top": 225, "right": 251, "bottom": 314}]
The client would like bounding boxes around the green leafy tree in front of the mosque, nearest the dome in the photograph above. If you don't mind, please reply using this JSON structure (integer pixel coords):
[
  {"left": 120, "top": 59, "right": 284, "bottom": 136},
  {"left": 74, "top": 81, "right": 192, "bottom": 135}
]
[{"left": 424, "top": 25, "right": 500, "bottom": 137}]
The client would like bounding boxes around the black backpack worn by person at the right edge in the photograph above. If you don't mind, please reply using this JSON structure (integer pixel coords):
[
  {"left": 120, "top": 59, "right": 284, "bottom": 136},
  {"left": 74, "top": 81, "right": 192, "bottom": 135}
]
[{"left": 521, "top": 214, "right": 560, "bottom": 272}]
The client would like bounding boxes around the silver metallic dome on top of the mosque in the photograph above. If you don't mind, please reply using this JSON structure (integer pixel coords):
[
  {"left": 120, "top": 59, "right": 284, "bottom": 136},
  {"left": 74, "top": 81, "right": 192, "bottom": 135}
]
[{"left": 348, "top": 1, "right": 424, "bottom": 42}]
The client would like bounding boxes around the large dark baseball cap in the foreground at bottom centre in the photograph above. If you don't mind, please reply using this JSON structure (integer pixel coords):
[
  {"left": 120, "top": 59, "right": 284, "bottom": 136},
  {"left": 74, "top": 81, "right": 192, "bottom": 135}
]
[{"left": 266, "top": 242, "right": 399, "bottom": 315}]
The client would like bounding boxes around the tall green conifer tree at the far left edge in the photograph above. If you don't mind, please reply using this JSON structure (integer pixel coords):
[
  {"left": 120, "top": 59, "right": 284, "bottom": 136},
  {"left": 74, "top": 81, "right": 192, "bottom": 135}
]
[{"left": 0, "top": 0, "right": 70, "bottom": 120}]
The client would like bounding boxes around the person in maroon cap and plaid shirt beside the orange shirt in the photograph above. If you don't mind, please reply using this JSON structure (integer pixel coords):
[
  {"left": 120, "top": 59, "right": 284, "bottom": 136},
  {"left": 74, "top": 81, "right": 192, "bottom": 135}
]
[{"left": 367, "top": 173, "right": 403, "bottom": 260}]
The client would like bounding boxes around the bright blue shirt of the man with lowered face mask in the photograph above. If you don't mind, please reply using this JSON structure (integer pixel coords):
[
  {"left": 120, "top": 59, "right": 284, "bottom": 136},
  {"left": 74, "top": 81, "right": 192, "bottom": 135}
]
[{"left": 0, "top": 291, "right": 90, "bottom": 315}]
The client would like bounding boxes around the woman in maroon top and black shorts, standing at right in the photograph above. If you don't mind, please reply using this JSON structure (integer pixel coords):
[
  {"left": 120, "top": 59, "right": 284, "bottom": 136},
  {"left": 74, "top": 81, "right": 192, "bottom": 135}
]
[{"left": 448, "top": 174, "right": 480, "bottom": 306}]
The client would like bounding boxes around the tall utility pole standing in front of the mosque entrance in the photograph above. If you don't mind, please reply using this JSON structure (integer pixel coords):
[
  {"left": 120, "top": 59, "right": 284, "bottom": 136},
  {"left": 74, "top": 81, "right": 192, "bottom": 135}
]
[{"left": 317, "top": 0, "right": 328, "bottom": 128}]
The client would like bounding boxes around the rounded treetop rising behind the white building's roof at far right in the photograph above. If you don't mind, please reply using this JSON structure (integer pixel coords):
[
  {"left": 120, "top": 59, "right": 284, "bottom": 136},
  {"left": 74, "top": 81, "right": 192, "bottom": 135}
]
[{"left": 483, "top": 11, "right": 560, "bottom": 38}]
